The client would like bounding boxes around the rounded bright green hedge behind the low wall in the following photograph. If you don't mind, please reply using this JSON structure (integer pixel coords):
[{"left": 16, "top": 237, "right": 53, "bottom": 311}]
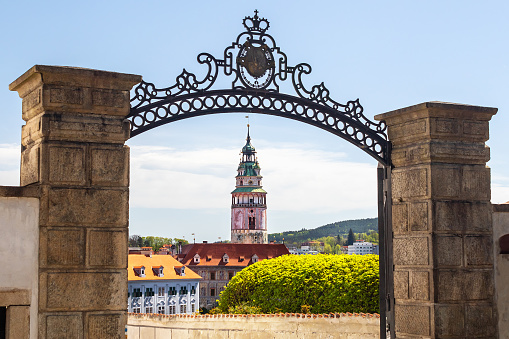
[{"left": 218, "top": 254, "right": 379, "bottom": 313}]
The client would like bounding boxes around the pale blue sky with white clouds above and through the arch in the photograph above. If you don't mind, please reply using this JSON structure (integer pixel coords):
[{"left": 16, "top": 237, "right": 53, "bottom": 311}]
[{"left": 0, "top": 1, "right": 509, "bottom": 241}]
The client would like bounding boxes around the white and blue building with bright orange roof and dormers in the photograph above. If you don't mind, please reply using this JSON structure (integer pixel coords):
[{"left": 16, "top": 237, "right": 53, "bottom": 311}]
[{"left": 127, "top": 254, "right": 201, "bottom": 314}]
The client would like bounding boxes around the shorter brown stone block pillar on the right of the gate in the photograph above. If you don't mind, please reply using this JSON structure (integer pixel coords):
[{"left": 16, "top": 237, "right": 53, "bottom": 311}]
[{"left": 375, "top": 102, "right": 497, "bottom": 338}]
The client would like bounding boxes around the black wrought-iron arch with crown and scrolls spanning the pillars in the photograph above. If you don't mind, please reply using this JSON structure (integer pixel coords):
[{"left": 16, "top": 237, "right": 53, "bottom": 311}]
[{"left": 127, "top": 11, "right": 390, "bottom": 165}]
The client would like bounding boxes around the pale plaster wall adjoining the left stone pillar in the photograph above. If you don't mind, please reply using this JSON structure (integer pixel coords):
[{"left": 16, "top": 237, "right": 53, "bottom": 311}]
[{"left": 0, "top": 197, "right": 39, "bottom": 338}]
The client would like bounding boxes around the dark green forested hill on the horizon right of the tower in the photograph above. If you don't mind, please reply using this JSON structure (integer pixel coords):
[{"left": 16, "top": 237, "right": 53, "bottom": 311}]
[{"left": 269, "top": 218, "right": 378, "bottom": 243}]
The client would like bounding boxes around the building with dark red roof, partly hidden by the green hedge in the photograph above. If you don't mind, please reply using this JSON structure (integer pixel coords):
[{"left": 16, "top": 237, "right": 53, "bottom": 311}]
[{"left": 177, "top": 243, "right": 290, "bottom": 309}]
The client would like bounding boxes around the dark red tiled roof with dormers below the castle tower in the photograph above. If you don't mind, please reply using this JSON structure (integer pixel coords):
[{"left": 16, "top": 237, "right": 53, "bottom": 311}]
[{"left": 181, "top": 243, "right": 290, "bottom": 266}]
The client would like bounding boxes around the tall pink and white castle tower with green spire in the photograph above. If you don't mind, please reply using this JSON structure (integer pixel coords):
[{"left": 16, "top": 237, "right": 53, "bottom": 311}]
[{"left": 231, "top": 124, "right": 268, "bottom": 244}]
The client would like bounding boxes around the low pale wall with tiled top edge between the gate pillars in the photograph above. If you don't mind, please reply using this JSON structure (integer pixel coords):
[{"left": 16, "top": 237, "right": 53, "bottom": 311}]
[{"left": 127, "top": 313, "right": 380, "bottom": 339}]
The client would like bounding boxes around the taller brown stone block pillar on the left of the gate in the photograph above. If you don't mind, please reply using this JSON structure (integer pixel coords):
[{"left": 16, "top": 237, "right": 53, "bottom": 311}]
[{"left": 9, "top": 65, "right": 141, "bottom": 339}]
